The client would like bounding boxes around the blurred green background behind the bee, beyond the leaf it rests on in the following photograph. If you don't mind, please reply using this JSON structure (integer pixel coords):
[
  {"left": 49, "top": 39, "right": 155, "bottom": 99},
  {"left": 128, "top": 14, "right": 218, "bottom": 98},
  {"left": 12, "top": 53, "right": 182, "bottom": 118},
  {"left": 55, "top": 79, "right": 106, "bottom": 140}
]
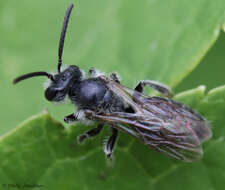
[{"left": 0, "top": 0, "right": 225, "bottom": 135}]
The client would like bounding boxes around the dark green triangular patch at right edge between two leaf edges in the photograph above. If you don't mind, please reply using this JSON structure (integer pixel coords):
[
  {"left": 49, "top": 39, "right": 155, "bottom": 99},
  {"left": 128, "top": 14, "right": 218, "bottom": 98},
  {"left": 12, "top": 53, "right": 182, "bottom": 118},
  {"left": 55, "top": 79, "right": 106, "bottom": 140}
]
[{"left": 175, "top": 32, "right": 225, "bottom": 92}]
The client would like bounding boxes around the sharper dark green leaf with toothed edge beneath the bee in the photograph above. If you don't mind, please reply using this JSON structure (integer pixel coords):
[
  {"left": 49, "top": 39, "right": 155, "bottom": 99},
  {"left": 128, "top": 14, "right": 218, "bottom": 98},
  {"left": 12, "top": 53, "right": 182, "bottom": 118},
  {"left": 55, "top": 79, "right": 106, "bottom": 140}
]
[{"left": 0, "top": 86, "right": 225, "bottom": 190}]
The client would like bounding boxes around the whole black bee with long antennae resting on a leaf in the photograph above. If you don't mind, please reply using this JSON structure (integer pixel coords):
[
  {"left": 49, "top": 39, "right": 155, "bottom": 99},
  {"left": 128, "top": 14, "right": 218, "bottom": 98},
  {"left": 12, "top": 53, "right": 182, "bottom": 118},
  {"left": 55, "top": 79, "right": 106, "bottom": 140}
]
[{"left": 13, "top": 4, "right": 212, "bottom": 162}]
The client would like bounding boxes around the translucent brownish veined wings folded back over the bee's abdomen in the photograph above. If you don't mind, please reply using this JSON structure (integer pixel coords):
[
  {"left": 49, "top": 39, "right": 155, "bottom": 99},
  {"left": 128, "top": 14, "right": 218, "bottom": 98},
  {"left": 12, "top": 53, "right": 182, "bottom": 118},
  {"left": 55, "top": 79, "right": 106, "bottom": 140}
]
[{"left": 85, "top": 77, "right": 211, "bottom": 162}]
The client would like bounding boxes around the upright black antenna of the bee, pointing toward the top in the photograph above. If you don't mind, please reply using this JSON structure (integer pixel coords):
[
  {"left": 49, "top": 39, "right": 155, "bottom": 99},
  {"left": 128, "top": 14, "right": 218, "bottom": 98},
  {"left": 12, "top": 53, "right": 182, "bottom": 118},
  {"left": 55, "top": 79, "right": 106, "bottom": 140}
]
[{"left": 58, "top": 4, "right": 73, "bottom": 73}]
